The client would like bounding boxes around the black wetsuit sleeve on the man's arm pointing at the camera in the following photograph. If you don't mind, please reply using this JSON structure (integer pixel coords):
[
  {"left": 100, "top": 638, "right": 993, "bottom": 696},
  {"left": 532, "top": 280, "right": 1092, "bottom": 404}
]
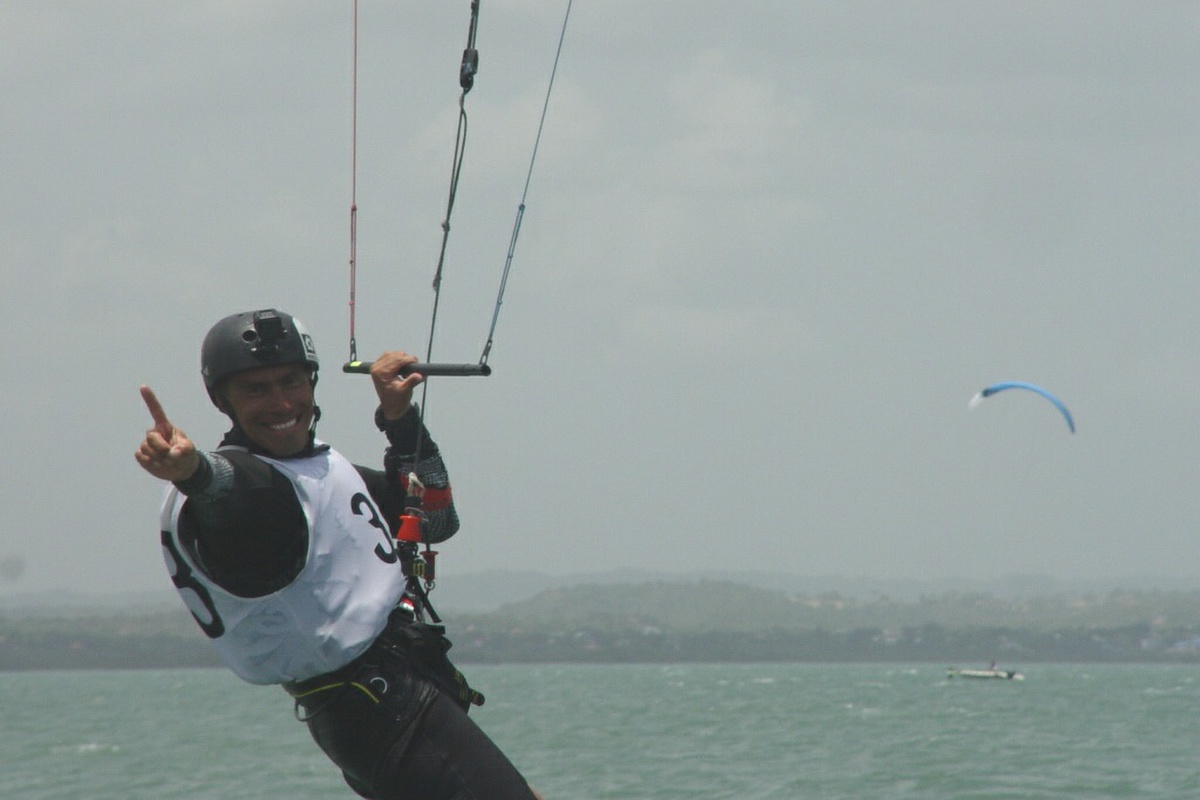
[{"left": 176, "top": 450, "right": 308, "bottom": 597}]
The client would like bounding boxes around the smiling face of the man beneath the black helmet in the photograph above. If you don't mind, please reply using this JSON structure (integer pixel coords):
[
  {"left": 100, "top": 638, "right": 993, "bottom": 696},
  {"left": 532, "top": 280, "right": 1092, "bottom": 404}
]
[{"left": 220, "top": 363, "right": 316, "bottom": 458}]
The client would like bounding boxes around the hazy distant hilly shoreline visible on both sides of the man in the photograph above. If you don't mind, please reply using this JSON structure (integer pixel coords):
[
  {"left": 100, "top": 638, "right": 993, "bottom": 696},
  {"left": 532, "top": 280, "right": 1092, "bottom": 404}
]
[{"left": 7, "top": 582, "right": 1200, "bottom": 670}]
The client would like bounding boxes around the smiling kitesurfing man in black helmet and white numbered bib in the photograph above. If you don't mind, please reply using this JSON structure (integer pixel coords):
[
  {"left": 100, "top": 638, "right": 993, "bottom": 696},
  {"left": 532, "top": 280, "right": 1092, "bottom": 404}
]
[{"left": 134, "top": 309, "right": 538, "bottom": 800}]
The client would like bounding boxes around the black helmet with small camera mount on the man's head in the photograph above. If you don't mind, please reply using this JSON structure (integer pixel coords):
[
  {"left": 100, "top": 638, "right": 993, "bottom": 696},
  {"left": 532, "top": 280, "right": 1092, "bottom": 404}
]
[{"left": 200, "top": 308, "right": 318, "bottom": 408}]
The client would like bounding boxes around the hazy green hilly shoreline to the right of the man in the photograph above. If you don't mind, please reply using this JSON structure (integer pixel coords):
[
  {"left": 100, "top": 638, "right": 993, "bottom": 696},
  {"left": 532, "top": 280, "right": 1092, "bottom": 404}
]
[{"left": 451, "top": 581, "right": 1200, "bottom": 663}]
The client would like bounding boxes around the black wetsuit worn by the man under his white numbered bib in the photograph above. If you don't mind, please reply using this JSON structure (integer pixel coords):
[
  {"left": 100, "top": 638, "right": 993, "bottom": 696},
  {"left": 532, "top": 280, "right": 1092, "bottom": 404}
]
[{"left": 178, "top": 410, "right": 534, "bottom": 800}]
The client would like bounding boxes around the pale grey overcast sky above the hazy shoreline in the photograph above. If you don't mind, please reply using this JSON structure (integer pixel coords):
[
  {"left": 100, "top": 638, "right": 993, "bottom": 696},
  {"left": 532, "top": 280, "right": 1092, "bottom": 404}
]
[{"left": 0, "top": 0, "right": 1200, "bottom": 596}]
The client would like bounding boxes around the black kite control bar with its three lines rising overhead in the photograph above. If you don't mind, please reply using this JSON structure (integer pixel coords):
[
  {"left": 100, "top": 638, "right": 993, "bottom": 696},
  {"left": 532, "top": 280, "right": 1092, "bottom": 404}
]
[{"left": 342, "top": 0, "right": 574, "bottom": 381}]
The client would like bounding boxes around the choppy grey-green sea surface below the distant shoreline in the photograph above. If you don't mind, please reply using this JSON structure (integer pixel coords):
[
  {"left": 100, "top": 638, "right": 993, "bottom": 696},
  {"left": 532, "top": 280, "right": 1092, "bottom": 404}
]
[{"left": 0, "top": 664, "right": 1200, "bottom": 800}]
